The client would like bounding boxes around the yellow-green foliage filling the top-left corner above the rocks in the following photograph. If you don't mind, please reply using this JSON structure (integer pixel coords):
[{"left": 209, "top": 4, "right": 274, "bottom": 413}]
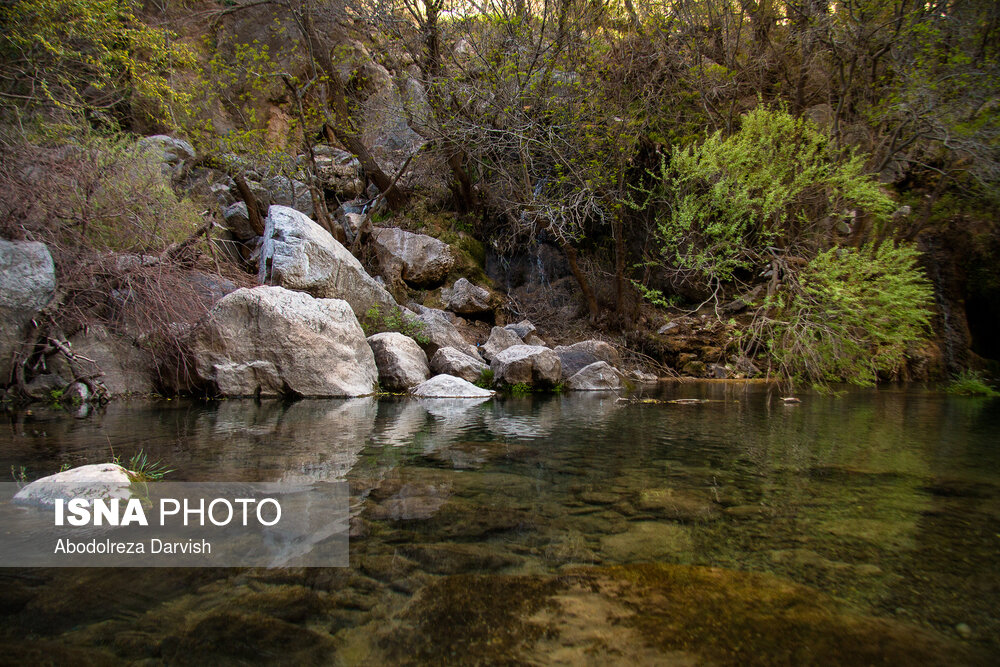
[{"left": 0, "top": 0, "right": 193, "bottom": 127}]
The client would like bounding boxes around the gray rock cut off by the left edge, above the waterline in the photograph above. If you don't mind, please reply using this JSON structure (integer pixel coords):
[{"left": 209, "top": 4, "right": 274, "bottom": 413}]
[{"left": 0, "top": 239, "right": 56, "bottom": 384}]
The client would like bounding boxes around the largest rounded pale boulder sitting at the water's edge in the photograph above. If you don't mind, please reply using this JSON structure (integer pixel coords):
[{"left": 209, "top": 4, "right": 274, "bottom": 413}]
[{"left": 190, "top": 287, "right": 378, "bottom": 397}]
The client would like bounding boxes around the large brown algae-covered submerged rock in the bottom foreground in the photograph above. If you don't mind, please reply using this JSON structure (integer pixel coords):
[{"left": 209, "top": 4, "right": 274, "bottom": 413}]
[{"left": 370, "top": 563, "right": 972, "bottom": 665}]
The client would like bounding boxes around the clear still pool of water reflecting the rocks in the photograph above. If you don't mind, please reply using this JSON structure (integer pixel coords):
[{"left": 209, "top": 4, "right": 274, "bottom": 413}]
[{"left": 0, "top": 383, "right": 1000, "bottom": 664}]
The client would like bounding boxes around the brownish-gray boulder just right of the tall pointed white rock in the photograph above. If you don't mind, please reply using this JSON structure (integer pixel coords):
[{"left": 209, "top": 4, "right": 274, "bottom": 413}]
[{"left": 373, "top": 227, "right": 455, "bottom": 287}]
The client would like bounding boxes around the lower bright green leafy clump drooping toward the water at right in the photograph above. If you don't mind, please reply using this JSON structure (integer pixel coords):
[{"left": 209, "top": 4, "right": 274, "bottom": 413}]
[{"left": 755, "top": 243, "right": 932, "bottom": 385}]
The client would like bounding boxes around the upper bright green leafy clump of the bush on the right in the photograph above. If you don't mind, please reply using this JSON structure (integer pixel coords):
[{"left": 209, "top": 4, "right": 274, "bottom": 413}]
[{"left": 636, "top": 105, "right": 893, "bottom": 284}]
